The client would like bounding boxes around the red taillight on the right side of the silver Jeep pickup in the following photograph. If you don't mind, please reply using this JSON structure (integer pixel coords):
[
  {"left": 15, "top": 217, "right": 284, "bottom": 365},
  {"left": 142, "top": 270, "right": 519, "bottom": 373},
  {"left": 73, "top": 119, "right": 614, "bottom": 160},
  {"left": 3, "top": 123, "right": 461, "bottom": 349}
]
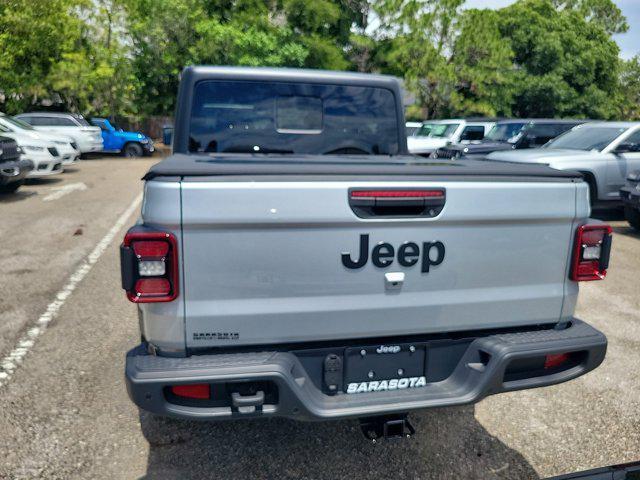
[{"left": 571, "top": 225, "right": 612, "bottom": 282}]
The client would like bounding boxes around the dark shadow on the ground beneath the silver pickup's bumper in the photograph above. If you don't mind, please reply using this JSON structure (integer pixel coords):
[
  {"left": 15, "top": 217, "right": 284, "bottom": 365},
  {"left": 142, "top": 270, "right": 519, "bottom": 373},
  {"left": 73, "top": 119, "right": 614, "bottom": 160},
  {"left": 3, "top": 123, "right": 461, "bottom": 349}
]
[{"left": 141, "top": 406, "right": 539, "bottom": 480}]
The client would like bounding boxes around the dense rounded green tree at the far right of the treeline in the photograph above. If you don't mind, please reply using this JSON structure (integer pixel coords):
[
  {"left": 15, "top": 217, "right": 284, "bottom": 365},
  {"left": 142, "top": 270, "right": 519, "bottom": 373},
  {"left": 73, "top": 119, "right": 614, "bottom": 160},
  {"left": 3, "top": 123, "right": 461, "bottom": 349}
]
[{"left": 499, "top": 0, "right": 619, "bottom": 119}]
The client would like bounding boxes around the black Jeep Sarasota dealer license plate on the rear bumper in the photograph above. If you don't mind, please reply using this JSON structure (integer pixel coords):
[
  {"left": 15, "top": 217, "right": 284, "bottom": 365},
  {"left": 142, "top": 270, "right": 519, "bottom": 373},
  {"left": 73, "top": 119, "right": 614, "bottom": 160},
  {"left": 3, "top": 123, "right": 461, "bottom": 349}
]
[{"left": 345, "top": 344, "right": 426, "bottom": 393}]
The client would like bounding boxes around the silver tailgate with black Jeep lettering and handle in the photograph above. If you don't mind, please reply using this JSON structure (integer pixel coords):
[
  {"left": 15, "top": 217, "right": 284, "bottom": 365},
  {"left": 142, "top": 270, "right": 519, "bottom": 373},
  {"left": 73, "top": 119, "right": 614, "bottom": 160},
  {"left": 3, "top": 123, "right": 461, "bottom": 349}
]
[{"left": 181, "top": 179, "right": 576, "bottom": 347}]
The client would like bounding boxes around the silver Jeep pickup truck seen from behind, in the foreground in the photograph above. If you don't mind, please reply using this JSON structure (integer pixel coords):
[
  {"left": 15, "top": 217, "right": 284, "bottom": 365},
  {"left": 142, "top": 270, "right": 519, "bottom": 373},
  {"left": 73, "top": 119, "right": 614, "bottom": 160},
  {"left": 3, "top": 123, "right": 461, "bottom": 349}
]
[{"left": 121, "top": 67, "right": 611, "bottom": 439}]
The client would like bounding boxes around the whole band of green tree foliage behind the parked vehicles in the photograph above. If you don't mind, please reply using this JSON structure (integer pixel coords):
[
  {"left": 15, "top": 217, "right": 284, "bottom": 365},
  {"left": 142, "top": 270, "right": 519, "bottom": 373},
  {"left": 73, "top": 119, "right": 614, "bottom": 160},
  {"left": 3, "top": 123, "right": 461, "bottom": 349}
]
[{"left": 0, "top": 0, "right": 640, "bottom": 122}]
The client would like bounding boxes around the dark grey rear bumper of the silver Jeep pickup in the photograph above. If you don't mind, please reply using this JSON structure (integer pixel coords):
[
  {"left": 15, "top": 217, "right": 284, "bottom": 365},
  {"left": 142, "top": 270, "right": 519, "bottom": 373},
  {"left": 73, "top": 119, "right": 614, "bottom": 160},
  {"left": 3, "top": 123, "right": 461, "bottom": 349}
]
[{"left": 126, "top": 319, "right": 607, "bottom": 420}]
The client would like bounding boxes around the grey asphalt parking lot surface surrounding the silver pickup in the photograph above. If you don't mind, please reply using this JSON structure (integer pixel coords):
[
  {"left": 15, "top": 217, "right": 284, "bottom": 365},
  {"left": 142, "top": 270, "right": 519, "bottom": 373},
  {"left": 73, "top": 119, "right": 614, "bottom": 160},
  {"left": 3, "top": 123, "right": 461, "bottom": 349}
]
[{"left": 0, "top": 158, "right": 640, "bottom": 479}]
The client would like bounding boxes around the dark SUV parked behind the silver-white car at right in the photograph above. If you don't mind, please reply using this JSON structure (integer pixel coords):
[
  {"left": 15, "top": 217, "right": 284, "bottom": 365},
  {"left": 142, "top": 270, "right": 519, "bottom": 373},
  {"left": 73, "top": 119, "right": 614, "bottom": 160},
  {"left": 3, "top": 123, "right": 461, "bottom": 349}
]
[{"left": 432, "top": 118, "right": 586, "bottom": 159}]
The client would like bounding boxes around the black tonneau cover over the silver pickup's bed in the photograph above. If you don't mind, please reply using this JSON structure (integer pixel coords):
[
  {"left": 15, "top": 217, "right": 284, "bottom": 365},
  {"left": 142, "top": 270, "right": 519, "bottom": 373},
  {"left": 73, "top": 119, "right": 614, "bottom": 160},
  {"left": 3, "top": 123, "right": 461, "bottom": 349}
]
[{"left": 143, "top": 153, "right": 581, "bottom": 181}]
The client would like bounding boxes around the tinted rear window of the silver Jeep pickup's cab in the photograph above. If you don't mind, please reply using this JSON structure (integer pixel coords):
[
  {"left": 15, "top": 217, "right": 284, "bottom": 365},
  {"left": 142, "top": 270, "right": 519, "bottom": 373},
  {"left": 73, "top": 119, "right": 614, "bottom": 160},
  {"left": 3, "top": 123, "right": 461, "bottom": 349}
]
[{"left": 189, "top": 80, "right": 399, "bottom": 155}]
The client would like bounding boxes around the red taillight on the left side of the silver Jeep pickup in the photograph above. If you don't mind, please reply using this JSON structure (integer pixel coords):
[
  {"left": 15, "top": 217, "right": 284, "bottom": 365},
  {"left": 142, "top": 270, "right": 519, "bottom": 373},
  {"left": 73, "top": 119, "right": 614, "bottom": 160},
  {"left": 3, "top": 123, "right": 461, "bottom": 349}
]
[{"left": 120, "top": 231, "right": 178, "bottom": 303}]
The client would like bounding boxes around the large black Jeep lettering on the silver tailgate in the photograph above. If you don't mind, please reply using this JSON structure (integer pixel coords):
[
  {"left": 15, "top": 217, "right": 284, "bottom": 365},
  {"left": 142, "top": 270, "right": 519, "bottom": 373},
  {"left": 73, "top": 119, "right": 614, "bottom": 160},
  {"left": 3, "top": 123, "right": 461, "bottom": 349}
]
[{"left": 342, "top": 233, "right": 445, "bottom": 273}]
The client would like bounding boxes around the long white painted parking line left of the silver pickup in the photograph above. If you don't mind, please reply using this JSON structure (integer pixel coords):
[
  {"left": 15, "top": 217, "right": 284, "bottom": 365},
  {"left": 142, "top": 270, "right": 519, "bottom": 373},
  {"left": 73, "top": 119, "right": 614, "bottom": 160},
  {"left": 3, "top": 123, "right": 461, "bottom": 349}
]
[{"left": 0, "top": 194, "right": 142, "bottom": 387}]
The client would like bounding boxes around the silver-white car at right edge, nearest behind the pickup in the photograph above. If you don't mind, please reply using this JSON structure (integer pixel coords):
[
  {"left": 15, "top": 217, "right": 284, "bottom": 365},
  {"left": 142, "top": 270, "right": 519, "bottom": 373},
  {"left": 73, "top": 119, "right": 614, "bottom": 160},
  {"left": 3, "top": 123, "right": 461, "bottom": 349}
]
[{"left": 487, "top": 122, "right": 640, "bottom": 204}]
